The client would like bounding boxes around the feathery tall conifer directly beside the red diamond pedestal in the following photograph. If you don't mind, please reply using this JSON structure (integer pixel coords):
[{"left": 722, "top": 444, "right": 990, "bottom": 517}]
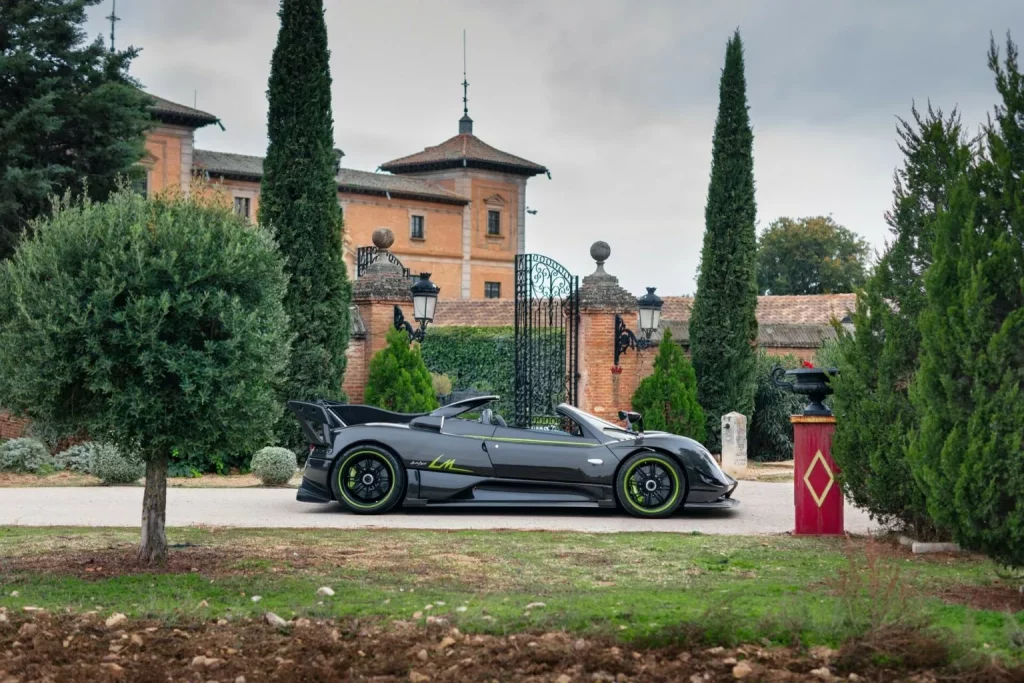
[{"left": 831, "top": 106, "right": 972, "bottom": 536}]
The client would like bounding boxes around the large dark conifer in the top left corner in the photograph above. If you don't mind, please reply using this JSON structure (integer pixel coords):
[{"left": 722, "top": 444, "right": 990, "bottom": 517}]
[{"left": 0, "top": 0, "right": 152, "bottom": 259}]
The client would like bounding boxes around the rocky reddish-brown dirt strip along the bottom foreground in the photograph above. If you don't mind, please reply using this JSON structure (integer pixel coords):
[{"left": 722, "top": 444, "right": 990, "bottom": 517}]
[{"left": 0, "top": 608, "right": 1024, "bottom": 683}]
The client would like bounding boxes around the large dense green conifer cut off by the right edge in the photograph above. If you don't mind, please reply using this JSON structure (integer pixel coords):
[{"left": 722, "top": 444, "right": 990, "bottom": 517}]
[{"left": 909, "top": 38, "right": 1024, "bottom": 566}]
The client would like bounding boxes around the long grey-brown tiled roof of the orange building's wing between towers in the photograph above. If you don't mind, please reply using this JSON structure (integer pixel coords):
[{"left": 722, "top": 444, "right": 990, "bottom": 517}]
[{"left": 194, "top": 150, "right": 469, "bottom": 204}]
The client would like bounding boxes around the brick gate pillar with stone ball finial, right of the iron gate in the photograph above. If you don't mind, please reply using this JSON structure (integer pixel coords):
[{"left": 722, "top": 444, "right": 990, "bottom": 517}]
[{"left": 580, "top": 242, "right": 640, "bottom": 423}]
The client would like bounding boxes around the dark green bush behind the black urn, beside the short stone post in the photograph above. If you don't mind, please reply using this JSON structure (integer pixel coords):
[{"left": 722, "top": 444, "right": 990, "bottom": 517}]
[{"left": 746, "top": 350, "right": 804, "bottom": 462}]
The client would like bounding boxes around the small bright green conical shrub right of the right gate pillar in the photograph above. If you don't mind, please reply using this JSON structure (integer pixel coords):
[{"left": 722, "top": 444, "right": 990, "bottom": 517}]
[{"left": 633, "top": 330, "right": 706, "bottom": 441}]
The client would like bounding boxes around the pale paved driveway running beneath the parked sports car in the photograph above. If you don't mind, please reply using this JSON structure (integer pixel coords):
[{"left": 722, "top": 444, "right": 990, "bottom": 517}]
[{"left": 0, "top": 481, "right": 872, "bottom": 535}]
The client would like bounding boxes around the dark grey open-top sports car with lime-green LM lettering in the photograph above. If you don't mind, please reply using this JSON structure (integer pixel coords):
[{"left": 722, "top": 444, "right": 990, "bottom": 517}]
[{"left": 288, "top": 396, "right": 737, "bottom": 517}]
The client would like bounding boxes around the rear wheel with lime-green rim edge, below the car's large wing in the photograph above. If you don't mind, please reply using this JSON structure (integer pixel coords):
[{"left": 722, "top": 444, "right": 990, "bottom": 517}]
[{"left": 331, "top": 445, "right": 406, "bottom": 515}]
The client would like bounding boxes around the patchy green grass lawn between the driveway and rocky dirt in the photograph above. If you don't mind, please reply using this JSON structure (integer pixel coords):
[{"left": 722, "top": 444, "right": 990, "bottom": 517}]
[{"left": 0, "top": 527, "right": 1024, "bottom": 661}]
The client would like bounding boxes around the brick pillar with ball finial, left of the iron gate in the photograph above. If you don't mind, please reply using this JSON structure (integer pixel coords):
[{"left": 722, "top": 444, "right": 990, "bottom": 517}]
[{"left": 349, "top": 227, "right": 413, "bottom": 402}]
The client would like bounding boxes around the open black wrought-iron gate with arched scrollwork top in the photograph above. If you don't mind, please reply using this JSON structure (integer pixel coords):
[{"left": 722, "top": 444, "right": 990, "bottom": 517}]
[{"left": 513, "top": 254, "right": 580, "bottom": 427}]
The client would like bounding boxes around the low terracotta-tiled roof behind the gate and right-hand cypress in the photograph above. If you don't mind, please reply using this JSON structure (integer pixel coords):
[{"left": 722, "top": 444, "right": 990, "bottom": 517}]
[{"left": 434, "top": 294, "right": 856, "bottom": 331}]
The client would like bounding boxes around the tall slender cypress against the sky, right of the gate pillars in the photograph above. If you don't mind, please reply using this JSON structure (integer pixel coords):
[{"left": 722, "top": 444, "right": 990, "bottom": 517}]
[{"left": 690, "top": 31, "right": 758, "bottom": 450}]
